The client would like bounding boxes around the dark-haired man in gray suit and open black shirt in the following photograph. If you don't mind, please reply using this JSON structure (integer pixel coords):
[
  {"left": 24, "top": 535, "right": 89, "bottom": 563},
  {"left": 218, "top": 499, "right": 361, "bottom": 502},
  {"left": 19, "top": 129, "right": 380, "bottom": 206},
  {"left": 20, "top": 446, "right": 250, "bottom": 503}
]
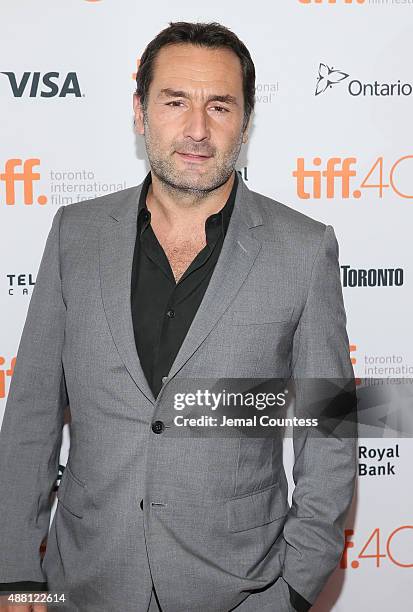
[{"left": 0, "top": 22, "right": 355, "bottom": 612}]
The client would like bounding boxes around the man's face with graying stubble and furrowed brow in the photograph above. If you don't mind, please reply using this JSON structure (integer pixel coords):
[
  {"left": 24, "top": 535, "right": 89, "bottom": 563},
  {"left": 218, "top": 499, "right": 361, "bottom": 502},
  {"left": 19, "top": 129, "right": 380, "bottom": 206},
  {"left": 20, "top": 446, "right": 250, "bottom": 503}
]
[{"left": 134, "top": 44, "right": 247, "bottom": 194}]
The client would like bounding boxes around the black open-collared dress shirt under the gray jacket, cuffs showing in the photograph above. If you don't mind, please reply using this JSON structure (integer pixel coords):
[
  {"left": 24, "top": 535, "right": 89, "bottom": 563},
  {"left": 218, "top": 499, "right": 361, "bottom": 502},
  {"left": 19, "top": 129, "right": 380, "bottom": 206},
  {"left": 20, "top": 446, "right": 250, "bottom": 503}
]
[{"left": 0, "top": 172, "right": 311, "bottom": 612}]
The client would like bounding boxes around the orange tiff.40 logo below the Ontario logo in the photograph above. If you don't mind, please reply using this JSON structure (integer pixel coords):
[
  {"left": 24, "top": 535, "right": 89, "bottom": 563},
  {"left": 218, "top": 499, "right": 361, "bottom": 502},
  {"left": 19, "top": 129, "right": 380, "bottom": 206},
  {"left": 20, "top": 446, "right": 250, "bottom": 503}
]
[{"left": 292, "top": 155, "right": 413, "bottom": 200}]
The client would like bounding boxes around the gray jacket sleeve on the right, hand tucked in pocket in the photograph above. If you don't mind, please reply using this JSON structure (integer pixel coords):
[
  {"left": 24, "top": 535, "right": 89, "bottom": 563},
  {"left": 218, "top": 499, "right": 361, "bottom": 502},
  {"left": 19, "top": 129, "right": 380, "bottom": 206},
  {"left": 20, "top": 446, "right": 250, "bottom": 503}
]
[{"left": 283, "top": 226, "right": 357, "bottom": 603}]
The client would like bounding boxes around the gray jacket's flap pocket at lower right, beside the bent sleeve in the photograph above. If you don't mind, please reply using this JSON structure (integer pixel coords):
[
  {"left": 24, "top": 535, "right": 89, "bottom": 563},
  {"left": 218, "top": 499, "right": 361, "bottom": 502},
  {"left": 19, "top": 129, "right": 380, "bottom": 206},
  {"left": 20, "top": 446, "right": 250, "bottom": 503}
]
[{"left": 226, "top": 482, "right": 289, "bottom": 531}]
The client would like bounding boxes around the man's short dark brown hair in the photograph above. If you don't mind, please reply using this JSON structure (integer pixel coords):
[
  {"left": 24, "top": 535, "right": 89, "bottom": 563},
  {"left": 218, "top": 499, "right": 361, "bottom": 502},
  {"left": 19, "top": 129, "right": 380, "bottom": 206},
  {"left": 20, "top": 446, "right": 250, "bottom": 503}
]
[{"left": 136, "top": 21, "right": 255, "bottom": 129}]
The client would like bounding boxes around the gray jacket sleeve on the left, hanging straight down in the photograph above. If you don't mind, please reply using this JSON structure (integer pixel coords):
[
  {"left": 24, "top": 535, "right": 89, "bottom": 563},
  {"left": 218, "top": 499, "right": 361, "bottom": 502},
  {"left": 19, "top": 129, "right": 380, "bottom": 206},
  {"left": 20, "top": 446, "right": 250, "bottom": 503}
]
[{"left": 0, "top": 207, "right": 68, "bottom": 591}]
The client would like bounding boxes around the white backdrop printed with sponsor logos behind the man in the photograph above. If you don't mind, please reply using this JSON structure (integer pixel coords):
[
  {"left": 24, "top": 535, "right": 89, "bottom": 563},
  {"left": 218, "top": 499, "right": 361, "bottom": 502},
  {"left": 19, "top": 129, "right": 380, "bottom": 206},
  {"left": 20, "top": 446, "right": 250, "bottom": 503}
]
[{"left": 0, "top": 0, "right": 413, "bottom": 612}]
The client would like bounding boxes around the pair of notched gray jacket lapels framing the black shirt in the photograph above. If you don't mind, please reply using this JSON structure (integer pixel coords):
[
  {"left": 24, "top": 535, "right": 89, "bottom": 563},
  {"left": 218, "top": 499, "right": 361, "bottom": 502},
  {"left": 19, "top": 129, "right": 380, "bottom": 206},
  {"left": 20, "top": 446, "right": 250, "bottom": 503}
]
[{"left": 99, "top": 173, "right": 262, "bottom": 404}]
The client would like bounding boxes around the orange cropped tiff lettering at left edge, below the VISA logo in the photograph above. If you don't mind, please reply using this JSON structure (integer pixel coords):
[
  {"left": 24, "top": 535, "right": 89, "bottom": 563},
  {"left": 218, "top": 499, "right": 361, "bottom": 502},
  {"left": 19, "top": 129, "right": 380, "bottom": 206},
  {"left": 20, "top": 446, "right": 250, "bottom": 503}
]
[{"left": 0, "top": 158, "right": 47, "bottom": 206}]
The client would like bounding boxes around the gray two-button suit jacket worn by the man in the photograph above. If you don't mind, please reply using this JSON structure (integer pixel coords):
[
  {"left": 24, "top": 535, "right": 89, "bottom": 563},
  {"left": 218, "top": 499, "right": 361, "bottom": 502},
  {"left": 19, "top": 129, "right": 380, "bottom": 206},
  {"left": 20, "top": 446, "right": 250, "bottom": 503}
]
[{"left": 0, "top": 175, "right": 356, "bottom": 612}]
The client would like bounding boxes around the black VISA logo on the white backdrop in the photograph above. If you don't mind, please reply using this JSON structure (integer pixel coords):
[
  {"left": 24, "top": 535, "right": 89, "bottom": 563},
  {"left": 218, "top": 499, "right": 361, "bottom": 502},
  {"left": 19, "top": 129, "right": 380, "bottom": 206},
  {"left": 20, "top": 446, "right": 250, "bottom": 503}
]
[{"left": 0, "top": 71, "right": 83, "bottom": 98}]
